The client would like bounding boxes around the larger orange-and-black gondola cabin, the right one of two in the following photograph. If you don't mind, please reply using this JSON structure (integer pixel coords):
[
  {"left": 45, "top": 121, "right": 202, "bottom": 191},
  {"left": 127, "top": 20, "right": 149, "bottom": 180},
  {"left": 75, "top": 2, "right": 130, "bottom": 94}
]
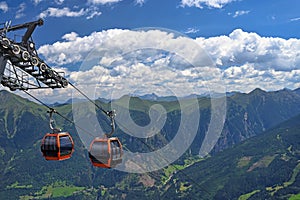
[{"left": 89, "top": 137, "right": 123, "bottom": 168}]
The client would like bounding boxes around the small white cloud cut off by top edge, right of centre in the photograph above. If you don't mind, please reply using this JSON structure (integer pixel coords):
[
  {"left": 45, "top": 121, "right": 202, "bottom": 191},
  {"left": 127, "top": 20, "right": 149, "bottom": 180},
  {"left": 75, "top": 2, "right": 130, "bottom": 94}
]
[{"left": 181, "top": 0, "right": 237, "bottom": 8}]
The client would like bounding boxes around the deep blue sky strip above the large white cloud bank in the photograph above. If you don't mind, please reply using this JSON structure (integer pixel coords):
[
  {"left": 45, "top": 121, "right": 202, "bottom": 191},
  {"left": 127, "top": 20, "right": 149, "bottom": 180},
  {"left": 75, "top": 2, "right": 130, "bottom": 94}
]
[{"left": 0, "top": 0, "right": 300, "bottom": 44}]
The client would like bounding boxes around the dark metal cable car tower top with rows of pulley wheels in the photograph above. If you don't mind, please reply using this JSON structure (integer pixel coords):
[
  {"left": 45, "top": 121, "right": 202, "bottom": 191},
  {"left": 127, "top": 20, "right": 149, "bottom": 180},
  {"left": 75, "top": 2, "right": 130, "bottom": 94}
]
[{"left": 0, "top": 19, "right": 68, "bottom": 91}]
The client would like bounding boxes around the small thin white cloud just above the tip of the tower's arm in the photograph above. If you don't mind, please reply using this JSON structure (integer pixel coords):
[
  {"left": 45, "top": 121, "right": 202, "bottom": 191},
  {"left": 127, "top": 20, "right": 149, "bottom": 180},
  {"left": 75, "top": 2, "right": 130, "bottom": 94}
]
[{"left": 39, "top": 7, "right": 86, "bottom": 18}]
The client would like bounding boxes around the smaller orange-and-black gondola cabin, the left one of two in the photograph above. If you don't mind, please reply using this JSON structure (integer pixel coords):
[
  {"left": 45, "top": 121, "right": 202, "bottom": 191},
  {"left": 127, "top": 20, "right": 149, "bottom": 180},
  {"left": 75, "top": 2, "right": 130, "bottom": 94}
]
[{"left": 41, "top": 132, "right": 74, "bottom": 160}]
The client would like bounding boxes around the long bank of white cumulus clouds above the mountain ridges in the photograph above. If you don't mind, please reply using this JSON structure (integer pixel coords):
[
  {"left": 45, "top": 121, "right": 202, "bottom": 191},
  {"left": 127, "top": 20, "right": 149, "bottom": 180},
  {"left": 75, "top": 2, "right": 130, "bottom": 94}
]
[{"left": 34, "top": 29, "right": 300, "bottom": 102}]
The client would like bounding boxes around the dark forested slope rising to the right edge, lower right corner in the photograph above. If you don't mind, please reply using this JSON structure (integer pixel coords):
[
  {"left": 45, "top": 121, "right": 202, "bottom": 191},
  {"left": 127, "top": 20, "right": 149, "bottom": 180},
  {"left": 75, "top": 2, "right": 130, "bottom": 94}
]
[{"left": 165, "top": 113, "right": 300, "bottom": 200}]
